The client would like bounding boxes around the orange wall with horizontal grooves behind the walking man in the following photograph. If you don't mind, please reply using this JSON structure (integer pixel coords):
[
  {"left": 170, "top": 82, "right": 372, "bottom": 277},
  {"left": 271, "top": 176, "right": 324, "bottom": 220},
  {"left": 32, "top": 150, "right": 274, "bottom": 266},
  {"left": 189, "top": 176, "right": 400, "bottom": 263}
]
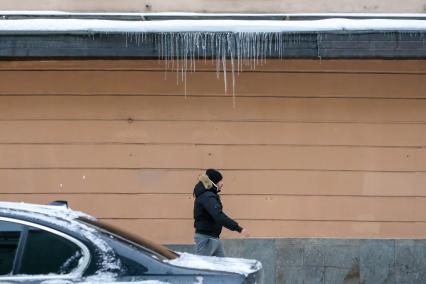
[{"left": 0, "top": 60, "right": 426, "bottom": 243}]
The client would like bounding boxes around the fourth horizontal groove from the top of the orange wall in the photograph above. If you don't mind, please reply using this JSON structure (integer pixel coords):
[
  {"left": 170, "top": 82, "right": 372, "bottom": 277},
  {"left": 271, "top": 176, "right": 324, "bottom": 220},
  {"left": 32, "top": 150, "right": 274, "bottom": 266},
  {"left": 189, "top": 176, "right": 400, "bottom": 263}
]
[{"left": 0, "top": 142, "right": 426, "bottom": 149}]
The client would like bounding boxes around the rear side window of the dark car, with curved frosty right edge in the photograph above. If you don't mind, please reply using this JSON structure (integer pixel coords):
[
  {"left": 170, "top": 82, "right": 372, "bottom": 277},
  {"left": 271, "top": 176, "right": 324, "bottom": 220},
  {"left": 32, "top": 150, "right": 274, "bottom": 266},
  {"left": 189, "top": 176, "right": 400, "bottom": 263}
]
[{"left": 18, "top": 227, "right": 82, "bottom": 275}]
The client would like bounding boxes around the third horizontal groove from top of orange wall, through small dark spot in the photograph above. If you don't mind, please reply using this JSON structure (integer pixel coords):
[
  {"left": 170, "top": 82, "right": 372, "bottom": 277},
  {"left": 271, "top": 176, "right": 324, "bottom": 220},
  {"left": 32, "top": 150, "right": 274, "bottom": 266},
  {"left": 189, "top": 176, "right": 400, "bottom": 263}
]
[{"left": 0, "top": 118, "right": 426, "bottom": 125}]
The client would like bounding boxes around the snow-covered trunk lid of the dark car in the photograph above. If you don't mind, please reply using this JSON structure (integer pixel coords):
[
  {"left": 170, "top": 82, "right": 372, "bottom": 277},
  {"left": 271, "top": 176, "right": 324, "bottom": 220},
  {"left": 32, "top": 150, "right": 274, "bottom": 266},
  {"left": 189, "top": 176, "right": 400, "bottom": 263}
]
[{"left": 165, "top": 253, "right": 262, "bottom": 276}]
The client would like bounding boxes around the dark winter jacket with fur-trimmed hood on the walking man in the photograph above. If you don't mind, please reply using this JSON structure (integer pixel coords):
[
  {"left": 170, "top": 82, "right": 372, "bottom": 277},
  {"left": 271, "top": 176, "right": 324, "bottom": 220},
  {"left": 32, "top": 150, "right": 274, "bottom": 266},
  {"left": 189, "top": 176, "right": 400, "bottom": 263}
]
[{"left": 194, "top": 175, "right": 243, "bottom": 238}]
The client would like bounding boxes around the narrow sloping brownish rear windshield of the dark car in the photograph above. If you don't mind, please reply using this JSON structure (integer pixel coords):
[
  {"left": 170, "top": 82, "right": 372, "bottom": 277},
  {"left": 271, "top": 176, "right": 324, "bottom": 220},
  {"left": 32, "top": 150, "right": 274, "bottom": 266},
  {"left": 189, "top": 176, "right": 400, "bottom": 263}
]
[{"left": 78, "top": 217, "right": 179, "bottom": 259}]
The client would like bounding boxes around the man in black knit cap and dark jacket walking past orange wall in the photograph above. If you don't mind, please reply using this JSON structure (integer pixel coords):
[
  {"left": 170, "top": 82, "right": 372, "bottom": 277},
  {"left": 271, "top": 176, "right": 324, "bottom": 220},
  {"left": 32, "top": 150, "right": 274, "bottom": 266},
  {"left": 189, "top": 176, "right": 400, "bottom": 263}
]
[{"left": 194, "top": 169, "right": 248, "bottom": 257}]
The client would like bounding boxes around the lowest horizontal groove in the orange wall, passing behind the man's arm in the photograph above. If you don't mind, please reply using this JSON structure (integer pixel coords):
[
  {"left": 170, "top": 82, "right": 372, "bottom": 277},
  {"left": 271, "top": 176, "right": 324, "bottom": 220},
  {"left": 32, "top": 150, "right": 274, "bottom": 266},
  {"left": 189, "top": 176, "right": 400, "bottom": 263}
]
[{"left": 96, "top": 217, "right": 426, "bottom": 224}]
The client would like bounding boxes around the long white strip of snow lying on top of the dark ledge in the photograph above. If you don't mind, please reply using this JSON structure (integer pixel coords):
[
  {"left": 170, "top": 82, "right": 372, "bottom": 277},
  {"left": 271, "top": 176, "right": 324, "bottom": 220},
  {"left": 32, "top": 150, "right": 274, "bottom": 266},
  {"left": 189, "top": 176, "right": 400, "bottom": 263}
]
[{"left": 0, "top": 18, "right": 426, "bottom": 34}]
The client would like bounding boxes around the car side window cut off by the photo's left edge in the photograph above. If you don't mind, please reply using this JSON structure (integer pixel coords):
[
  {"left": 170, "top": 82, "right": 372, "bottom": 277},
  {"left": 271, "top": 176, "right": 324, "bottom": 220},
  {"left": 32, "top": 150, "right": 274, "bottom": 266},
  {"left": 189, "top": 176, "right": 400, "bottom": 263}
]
[{"left": 0, "top": 221, "right": 22, "bottom": 276}]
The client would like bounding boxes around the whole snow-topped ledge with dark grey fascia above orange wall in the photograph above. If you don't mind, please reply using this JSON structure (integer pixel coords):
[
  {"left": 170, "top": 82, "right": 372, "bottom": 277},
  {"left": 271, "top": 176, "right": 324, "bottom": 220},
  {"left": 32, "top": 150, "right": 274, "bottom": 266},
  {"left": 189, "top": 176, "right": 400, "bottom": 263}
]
[{"left": 0, "top": 11, "right": 426, "bottom": 61}]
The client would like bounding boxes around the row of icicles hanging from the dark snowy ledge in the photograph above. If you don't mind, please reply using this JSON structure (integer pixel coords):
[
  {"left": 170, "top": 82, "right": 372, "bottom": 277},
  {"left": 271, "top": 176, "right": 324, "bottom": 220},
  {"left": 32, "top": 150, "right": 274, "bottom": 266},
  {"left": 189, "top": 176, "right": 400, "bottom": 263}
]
[{"left": 120, "top": 32, "right": 312, "bottom": 106}]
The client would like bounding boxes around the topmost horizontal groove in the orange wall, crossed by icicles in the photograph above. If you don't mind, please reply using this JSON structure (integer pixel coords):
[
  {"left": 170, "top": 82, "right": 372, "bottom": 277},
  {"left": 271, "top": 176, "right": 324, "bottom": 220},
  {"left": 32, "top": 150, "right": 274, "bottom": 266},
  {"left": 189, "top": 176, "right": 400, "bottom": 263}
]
[{"left": 0, "top": 69, "right": 426, "bottom": 75}]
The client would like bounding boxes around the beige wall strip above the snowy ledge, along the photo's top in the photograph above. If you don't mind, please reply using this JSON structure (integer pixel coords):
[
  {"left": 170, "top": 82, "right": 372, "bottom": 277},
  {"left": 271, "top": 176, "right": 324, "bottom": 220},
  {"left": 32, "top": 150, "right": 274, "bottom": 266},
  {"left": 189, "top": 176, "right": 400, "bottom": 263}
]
[{"left": 0, "top": 0, "right": 426, "bottom": 13}]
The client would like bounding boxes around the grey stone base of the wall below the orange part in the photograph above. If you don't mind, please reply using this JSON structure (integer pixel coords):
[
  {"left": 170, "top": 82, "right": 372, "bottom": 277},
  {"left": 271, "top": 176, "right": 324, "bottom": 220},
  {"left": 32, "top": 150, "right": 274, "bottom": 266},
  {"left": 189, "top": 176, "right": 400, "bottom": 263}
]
[{"left": 169, "top": 239, "right": 426, "bottom": 284}]
